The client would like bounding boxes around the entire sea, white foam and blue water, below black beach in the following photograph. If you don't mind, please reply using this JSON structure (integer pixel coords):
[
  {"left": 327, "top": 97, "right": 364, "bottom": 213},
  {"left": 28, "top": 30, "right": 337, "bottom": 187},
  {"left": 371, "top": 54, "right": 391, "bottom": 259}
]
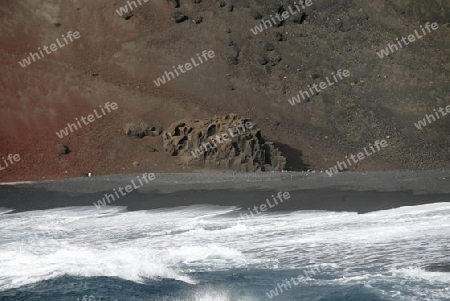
[{"left": 0, "top": 203, "right": 450, "bottom": 301}]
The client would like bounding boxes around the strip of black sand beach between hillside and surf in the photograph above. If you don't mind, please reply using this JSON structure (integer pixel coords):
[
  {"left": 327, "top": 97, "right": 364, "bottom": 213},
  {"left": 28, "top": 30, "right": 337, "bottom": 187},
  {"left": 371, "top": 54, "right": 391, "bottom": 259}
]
[{"left": 0, "top": 171, "right": 450, "bottom": 213}]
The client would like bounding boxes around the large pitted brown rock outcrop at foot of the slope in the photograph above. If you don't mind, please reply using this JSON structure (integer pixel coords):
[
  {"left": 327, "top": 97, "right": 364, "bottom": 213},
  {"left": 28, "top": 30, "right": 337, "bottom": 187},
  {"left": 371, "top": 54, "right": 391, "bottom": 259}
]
[{"left": 163, "top": 114, "right": 286, "bottom": 171}]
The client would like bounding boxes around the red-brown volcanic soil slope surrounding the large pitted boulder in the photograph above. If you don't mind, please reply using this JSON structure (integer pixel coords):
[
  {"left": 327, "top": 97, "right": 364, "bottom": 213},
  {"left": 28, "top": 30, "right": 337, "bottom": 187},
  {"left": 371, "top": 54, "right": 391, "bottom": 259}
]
[{"left": 0, "top": 0, "right": 450, "bottom": 182}]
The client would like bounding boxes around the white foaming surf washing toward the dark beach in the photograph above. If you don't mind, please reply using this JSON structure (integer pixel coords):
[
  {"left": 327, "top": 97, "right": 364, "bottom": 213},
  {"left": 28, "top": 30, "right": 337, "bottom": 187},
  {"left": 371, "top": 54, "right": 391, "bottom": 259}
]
[{"left": 0, "top": 203, "right": 450, "bottom": 300}]
